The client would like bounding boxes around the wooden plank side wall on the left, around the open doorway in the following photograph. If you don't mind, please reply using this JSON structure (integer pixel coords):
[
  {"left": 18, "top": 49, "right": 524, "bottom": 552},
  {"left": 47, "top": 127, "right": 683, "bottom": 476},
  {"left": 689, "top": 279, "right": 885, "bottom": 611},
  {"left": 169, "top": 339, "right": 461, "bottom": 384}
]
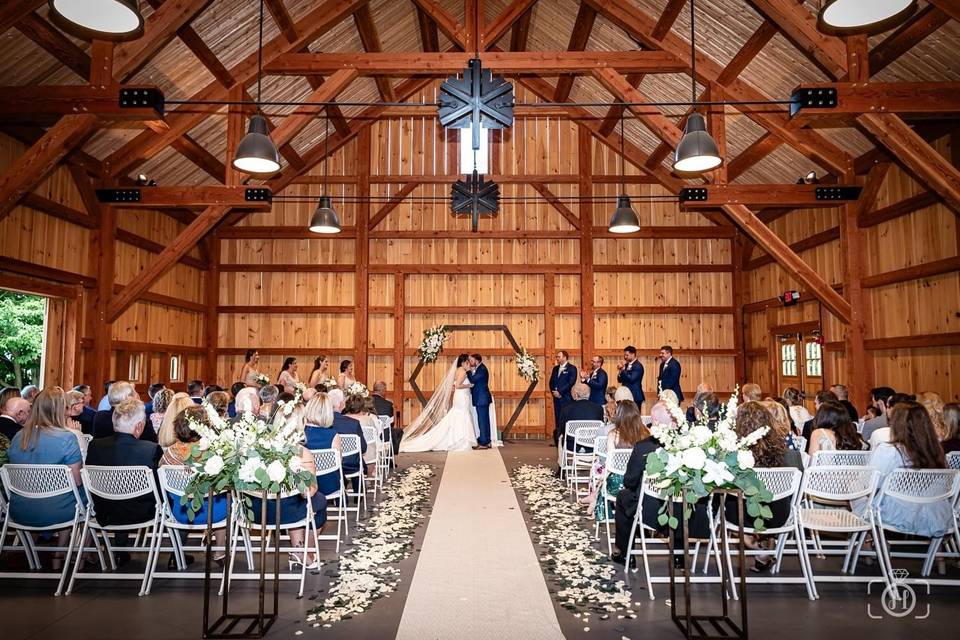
[{"left": 0, "top": 135, "right": 204, "bottom": 390}]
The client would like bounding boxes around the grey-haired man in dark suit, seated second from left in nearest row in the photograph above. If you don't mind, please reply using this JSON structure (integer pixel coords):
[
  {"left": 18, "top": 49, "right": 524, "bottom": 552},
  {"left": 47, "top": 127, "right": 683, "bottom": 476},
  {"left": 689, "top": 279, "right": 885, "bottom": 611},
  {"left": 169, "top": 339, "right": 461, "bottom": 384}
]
[{"left": 87, "top": 400, "right": 169, "bottom": 545}]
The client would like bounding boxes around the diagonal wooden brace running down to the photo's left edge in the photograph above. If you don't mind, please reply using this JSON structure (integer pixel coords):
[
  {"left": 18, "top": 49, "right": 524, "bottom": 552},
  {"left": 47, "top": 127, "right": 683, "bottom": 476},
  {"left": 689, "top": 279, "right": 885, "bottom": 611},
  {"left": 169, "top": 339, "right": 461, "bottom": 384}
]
[{"left": 0, "top": 114, "right": 97, "bottom": 220}]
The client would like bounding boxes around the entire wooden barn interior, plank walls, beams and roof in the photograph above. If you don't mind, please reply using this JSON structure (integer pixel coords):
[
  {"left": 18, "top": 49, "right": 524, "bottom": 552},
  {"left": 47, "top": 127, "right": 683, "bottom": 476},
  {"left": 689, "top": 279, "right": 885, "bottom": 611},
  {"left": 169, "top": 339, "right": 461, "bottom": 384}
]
[{"left": 0, "top": 0, "right": 960, "bottom": 438}]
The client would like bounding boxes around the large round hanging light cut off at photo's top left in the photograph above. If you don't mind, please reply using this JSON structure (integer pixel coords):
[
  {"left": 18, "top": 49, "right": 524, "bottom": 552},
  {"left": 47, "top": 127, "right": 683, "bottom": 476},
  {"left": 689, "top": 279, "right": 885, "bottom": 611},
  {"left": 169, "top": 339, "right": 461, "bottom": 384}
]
[{"left": 47, "top": 0, "right": 143, "bottom": 41}]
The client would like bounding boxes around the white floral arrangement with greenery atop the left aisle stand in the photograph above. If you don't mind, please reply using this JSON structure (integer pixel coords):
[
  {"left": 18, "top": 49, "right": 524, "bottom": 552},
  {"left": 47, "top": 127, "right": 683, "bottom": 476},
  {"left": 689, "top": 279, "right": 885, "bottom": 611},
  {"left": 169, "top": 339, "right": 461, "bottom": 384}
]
[{"left": 180, "top": 401, "right": 314, "bottom": 519}]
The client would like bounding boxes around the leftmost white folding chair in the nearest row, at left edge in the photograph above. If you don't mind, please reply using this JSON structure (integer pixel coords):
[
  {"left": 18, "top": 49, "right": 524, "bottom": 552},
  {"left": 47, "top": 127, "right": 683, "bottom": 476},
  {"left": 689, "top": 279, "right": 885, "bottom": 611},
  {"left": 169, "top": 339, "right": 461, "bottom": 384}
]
[{"left": 0, "top": 464, "right": 87, "bottom": 595}]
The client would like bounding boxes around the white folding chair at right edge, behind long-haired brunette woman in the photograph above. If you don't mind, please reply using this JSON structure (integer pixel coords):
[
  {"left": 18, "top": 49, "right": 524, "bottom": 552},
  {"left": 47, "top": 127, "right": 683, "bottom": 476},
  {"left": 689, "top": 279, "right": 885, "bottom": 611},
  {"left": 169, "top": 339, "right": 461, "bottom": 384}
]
[{"left": 872, "top": 469, "right": 960, "bottom": 577}]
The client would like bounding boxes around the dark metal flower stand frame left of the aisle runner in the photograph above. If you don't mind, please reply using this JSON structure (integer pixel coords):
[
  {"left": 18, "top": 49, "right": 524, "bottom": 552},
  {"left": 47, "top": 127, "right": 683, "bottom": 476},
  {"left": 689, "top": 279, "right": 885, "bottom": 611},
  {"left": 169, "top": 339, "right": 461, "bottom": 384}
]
[{"left": 203, "top": 491, "right": 280, "bottom": 640}]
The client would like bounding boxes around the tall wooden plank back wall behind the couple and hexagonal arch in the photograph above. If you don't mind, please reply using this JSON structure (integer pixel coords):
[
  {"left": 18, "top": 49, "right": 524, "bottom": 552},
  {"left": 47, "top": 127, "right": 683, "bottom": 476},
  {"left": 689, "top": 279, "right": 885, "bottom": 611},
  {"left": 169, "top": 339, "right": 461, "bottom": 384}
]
[{"left": 217, "top": 85, "right": 736, "bottom": 437}]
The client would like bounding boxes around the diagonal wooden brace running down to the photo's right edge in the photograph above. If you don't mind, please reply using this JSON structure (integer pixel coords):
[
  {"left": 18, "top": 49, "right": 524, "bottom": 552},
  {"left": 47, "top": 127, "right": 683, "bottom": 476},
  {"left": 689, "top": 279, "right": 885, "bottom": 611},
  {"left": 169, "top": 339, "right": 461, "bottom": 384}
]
[{"left": 857, "top": 113, "right": 960, "bottom": 214}]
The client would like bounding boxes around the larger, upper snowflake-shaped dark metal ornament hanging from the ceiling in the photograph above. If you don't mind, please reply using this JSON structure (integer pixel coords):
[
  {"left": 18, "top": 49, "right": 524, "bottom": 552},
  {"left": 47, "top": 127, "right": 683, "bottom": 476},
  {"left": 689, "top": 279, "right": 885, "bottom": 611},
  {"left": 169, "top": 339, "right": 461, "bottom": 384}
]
[{"left": 437, "top": 58, "right": 513, "bottom": 150}]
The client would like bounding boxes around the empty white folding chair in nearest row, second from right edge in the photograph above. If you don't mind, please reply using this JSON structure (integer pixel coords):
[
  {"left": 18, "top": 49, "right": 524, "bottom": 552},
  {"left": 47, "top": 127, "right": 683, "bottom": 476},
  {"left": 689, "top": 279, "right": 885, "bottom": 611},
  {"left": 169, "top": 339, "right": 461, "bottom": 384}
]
[{"left": 797, "top": 466, "right": 890, "bottom": 598}]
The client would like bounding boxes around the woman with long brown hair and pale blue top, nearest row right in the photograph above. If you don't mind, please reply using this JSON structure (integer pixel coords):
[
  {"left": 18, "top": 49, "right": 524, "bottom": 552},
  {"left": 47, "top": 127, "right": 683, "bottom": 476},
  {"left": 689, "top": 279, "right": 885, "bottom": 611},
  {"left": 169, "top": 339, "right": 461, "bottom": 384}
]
[{"left": 851, "top": 400, "right": 954, "bottom": 537}]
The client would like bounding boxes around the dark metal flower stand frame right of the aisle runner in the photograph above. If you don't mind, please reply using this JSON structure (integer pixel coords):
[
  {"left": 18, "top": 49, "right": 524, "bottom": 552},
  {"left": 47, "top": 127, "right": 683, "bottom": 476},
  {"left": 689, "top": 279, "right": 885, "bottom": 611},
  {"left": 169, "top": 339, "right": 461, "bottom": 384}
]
[{"left": 668, "top": 491, "right": 749, "bottom": 640}]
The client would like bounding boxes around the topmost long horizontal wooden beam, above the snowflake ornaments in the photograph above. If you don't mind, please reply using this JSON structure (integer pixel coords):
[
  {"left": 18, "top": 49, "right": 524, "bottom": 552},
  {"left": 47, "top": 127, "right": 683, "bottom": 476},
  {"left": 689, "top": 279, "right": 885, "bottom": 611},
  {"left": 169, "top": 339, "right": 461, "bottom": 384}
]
[{"left": 264, "top": 51, "right": 686, "bottom": 76}]
